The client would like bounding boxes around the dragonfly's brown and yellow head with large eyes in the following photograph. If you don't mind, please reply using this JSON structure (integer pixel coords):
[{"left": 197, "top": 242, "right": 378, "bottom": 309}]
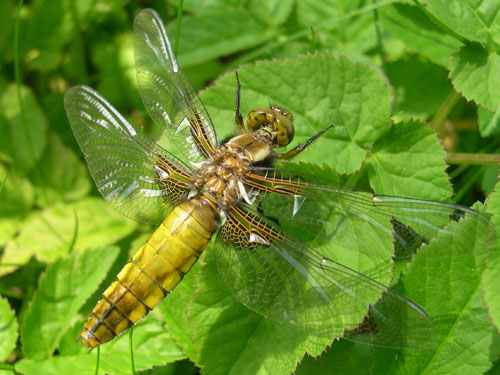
[{"left": 247, "top": 105, "right": 295, "bottom": 146}]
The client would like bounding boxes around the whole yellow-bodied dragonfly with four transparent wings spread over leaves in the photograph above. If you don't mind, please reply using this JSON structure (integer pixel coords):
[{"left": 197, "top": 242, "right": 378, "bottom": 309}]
[{"left": 64, "top": 9, "right": 486, "bottom": 349}]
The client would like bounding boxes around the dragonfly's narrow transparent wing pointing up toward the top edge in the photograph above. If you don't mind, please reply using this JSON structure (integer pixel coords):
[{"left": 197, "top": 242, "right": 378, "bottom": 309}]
[{"left": 134, "top": 9, "right": 219, "bottom": 162}]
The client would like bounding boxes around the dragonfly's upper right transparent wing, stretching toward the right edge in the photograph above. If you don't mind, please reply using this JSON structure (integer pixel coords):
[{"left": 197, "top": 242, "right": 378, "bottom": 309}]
[{"left": 247, "top": 166, "right": 489, "bottom": 258}]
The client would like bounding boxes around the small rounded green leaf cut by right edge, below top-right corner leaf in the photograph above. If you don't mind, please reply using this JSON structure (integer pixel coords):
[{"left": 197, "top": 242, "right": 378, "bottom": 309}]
[{"left": 448, "top": 44, "right": 500, "bottom": 112}]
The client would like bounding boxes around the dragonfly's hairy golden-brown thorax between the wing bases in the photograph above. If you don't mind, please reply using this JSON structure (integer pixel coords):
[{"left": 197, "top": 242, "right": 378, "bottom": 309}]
[{"left": 194, "top": 134, "right": 271, "bottom": 210}]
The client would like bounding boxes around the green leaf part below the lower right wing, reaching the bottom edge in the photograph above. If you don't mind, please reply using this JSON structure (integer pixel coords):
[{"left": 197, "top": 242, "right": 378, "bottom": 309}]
[{"left": 189, "top": 250, "right": 331, "bottom": 374}]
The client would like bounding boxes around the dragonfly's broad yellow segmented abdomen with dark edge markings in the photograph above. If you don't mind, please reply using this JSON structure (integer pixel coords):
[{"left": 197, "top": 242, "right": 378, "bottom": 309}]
[{"left": 80, "top": 198, "right": 218, "bottom": 348}]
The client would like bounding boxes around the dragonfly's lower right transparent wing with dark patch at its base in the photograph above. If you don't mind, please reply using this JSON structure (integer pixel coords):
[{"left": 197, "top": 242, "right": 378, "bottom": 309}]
[{"left": 215, "top": 203, "right": 434, "bottom": 349}]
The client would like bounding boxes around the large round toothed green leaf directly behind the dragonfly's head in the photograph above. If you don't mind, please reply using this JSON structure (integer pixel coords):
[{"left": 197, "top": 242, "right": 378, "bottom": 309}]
[{"left": 202, "top": 53, "right": 391, "bottom": 173}]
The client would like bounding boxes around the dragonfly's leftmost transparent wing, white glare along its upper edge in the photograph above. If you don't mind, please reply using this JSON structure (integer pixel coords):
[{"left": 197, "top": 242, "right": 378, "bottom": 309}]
[{"left": 64, "top": 86, "right": 192, "bottom": 224}]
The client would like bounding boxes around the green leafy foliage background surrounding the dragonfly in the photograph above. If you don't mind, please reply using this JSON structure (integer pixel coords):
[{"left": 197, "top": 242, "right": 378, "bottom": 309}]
[{"left": 0, "top": 0, "right": 500, "bottom": 375}]
